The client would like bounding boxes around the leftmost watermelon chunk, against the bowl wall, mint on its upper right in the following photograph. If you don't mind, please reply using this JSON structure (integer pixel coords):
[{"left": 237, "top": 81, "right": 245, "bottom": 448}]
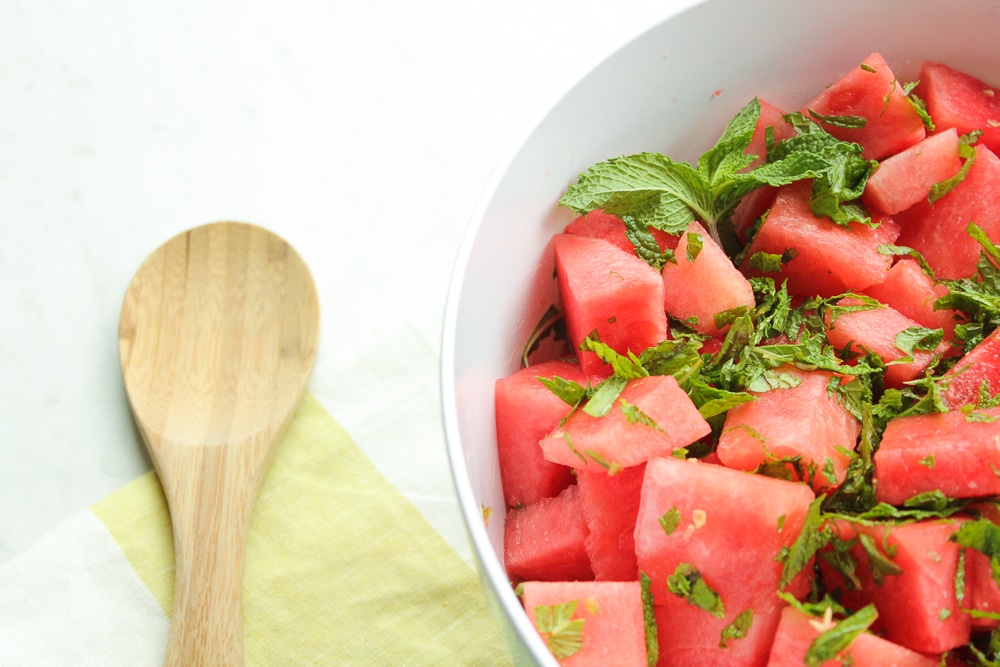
[{"left": 493, "top": 361, "right": 587, "bottom": 507}]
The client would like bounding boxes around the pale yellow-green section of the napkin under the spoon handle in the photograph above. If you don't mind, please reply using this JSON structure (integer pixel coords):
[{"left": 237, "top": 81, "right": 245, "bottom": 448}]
[{"left": 55, "top": 395, "right": 510, "bottom": 667}]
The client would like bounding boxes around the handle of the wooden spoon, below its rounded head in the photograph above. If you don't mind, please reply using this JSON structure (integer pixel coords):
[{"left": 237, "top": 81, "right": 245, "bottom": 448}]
[{"left": 161, "top": 438, "right": 265, "bottom": 667}]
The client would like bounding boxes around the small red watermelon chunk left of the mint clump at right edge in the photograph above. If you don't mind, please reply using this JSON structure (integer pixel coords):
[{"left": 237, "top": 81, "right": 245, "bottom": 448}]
[{"left": 864, "top": 257, "right": 963, "bottom": 341}]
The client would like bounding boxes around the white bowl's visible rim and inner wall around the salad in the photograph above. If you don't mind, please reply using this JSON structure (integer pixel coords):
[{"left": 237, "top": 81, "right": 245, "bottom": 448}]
[{"left": 442, "top": 0, "right": 1000, "bottom": 665}]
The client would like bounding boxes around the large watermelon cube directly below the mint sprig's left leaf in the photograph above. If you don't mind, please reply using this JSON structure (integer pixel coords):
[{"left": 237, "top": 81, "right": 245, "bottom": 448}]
[{"left": 553, "top": 234, "right": 667, "bottom": 377}]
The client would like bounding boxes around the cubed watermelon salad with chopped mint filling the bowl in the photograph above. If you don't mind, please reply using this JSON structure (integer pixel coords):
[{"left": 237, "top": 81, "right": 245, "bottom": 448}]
[{"left": 498, "top": 53, "right": 1000, "bottom": 667}]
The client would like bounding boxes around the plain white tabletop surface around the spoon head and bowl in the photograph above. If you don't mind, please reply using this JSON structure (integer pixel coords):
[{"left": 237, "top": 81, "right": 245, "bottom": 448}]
[{"left": 0, "top": 0, "right": 676, "bottom": 563}]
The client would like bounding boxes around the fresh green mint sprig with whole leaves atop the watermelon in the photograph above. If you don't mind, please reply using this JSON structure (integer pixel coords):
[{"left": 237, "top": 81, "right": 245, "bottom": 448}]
[{"left": 560, "top": 98, "right": 875, "bottom": 269}]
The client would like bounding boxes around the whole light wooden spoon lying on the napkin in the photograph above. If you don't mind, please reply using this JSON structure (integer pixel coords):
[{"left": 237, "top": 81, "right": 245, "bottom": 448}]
[{"left": 118, "top": 222, "right": 319, "bottom": 667}]
